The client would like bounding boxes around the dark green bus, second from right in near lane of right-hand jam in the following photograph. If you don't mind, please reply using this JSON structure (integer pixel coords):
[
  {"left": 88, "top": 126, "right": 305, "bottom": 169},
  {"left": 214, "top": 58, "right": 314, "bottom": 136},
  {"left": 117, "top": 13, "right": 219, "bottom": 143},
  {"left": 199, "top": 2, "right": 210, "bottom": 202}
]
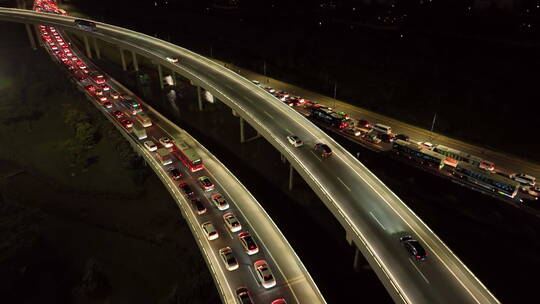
[{"left": 392, "top": 139, "right": 446, "bottom": 170}]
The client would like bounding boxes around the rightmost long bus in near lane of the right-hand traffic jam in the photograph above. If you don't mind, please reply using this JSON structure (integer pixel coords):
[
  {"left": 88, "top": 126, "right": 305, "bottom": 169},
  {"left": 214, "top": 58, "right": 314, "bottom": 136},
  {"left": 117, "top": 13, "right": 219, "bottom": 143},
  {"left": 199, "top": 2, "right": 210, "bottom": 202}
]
[{"left": 452, "top": 162, "right": 519, "bottom": 197}]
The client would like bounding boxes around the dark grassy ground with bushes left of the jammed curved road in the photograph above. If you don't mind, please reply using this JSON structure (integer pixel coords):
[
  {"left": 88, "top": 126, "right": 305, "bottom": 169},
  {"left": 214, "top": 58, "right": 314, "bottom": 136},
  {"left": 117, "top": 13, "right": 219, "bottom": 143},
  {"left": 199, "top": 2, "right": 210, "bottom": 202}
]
[{"left": 0, "top": 19, "right": 219, "bottom": 304}]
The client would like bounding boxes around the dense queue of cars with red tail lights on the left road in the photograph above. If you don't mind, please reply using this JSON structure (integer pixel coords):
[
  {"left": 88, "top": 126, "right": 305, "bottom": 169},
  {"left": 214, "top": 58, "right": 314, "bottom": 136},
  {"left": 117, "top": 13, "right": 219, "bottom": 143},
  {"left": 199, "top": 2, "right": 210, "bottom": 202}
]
[{"left": 34, "top": 0, "right": 287, "bottom": 304}]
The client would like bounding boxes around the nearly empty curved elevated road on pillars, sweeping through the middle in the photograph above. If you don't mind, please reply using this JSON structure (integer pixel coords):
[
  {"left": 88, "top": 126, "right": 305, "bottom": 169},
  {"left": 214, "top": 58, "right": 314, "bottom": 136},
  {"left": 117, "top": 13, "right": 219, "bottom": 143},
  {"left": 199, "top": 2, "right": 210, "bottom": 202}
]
[{"left": 0, "top": 9, "right": 498, "bottom": 304}]
